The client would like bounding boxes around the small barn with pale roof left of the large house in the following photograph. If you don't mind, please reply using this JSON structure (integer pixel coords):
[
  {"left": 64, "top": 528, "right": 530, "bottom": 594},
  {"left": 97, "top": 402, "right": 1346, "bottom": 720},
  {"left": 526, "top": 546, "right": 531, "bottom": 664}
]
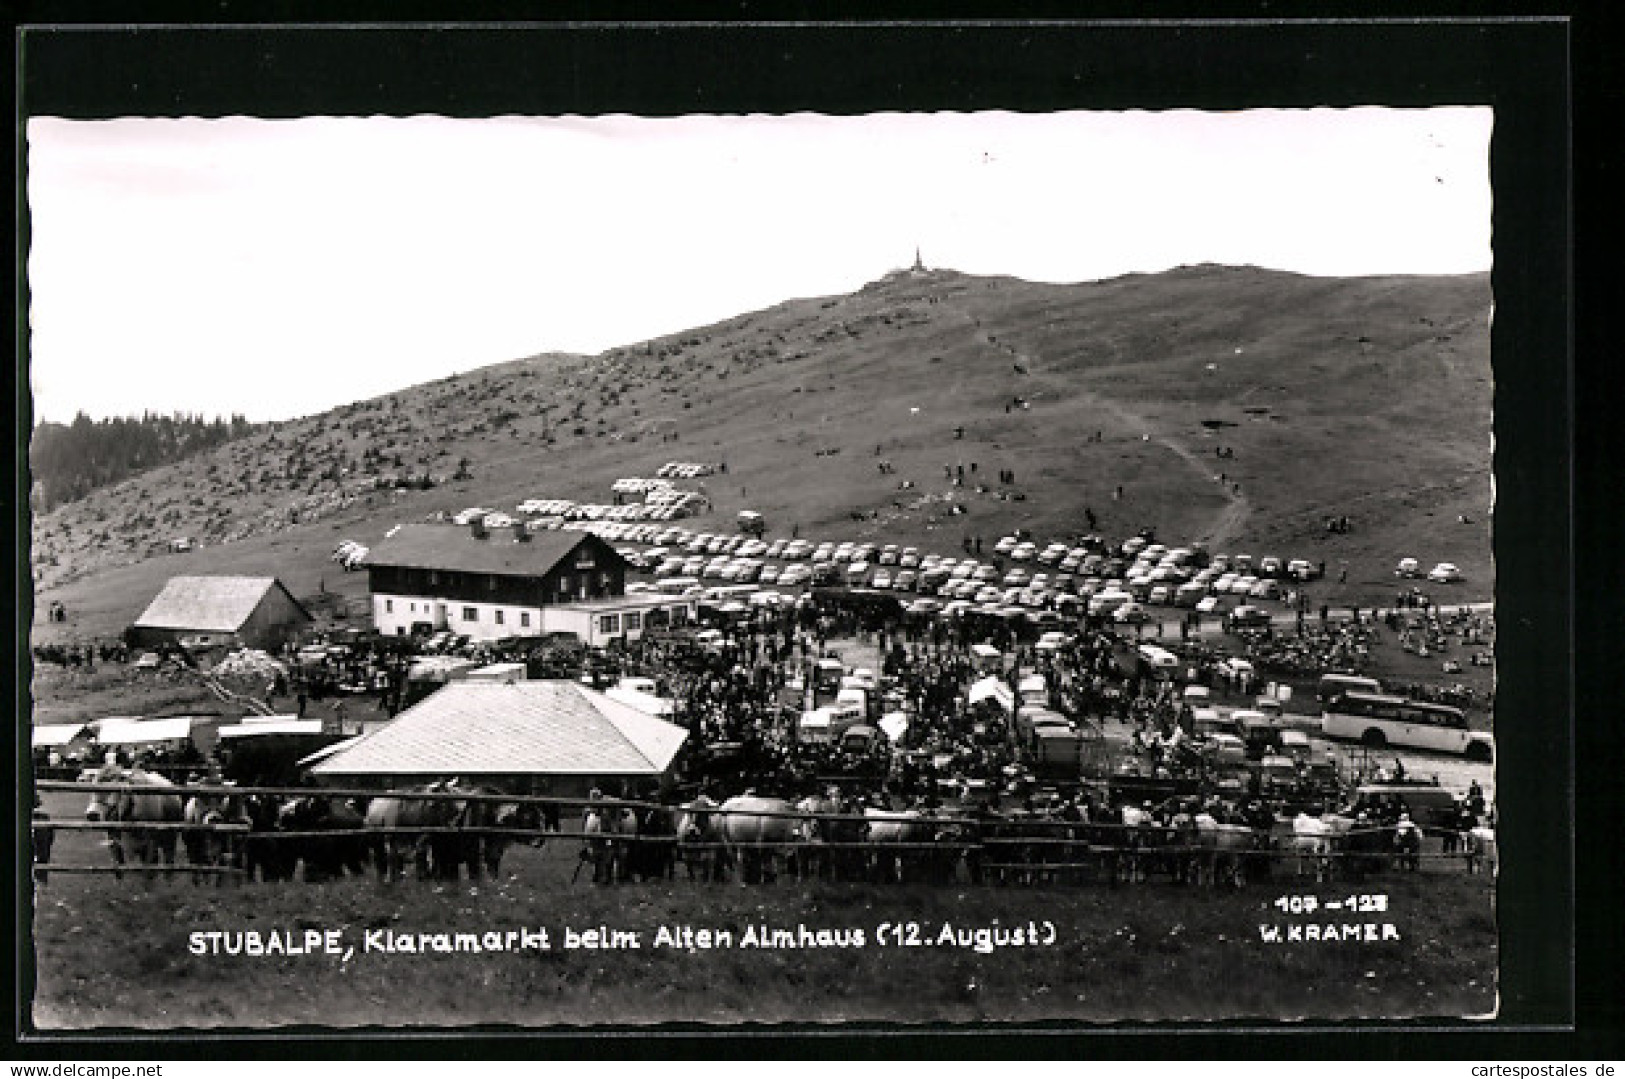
[{"left": 130, "top": 577, "right": 312, "bottom": 650}]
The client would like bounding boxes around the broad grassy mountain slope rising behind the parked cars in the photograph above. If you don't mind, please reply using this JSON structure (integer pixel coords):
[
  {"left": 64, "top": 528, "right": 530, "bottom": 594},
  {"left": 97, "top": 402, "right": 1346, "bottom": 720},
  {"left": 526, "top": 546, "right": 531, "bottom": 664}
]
[{"left": 34, "top": 267, "right": 1492, "bottom": 635}]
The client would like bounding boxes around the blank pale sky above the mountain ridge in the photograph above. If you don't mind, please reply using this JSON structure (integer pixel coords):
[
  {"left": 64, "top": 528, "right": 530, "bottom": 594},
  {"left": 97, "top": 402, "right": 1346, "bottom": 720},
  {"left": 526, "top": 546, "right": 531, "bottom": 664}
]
[{"left": 28, "top": 107, "right": 1492, "bottom": 421}]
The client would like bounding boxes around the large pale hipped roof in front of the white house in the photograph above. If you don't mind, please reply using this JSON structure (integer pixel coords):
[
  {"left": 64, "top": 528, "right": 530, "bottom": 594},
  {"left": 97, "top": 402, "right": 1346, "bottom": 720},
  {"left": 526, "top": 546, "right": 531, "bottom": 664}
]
[{"left": 312, "top": 679, "right": 687, "bottom": 777}]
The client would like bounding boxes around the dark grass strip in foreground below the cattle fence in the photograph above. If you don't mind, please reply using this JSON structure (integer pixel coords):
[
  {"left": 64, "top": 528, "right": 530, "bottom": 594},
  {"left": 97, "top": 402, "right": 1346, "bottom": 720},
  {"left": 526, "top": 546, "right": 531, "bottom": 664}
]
[{"left": 33, "top": 791, "right": 1497, "bottom": 1030}]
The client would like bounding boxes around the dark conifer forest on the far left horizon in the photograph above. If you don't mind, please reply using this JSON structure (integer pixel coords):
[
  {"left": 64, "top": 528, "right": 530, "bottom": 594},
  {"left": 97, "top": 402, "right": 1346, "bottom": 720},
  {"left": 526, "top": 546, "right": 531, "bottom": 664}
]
[{"left": 28, "top": 411, "right": 257, "bottom": 514}]
